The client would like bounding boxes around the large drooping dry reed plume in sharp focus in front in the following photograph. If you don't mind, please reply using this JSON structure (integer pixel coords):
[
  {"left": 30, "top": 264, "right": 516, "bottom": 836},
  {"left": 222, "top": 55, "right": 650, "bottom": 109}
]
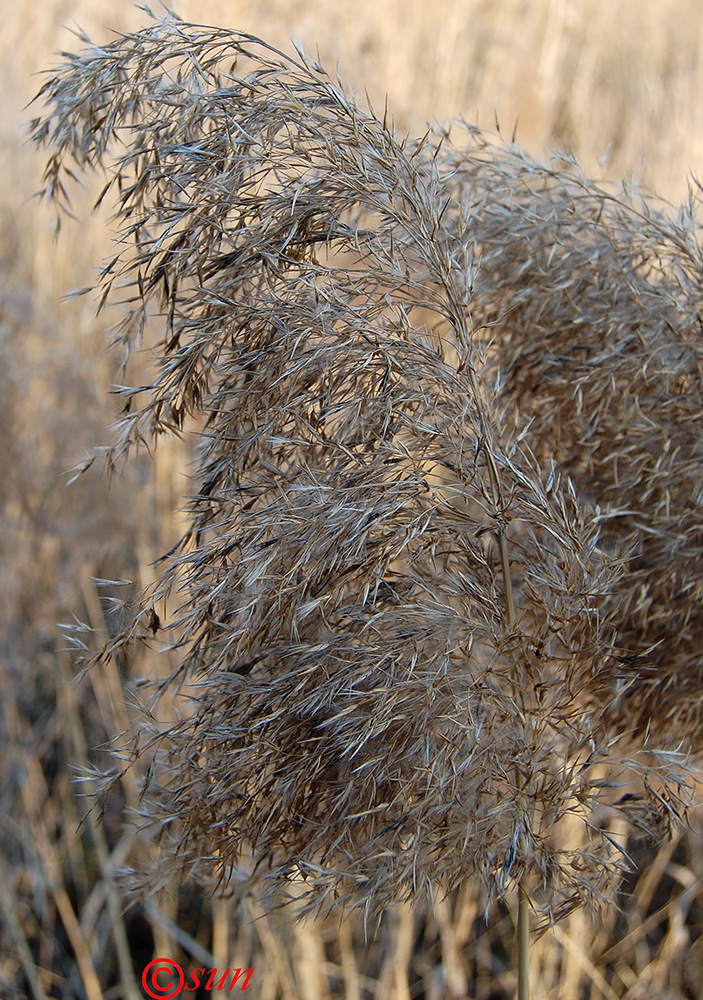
[{"left": 33, "top": 16, "right": 685, "bottom": 916}]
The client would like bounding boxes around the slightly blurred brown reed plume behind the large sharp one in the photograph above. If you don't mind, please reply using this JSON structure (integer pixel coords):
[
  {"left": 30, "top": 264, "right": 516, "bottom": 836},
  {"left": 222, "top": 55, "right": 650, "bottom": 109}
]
[{"left": 442, "top": 145, "right": 703, "bottom": 749}]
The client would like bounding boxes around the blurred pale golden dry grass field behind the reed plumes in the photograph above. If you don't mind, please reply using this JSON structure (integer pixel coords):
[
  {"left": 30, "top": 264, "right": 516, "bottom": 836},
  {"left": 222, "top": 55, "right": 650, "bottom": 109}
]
[{"left": 0, "top": 0, "right": 703, "bottom": 1000}]
